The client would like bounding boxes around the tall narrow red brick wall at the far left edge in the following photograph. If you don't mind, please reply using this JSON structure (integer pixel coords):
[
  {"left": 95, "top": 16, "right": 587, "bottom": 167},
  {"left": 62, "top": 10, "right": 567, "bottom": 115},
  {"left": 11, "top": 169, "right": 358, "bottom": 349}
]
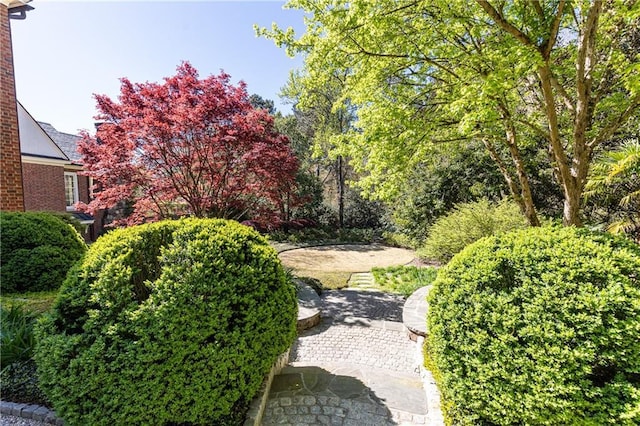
[{"left": 0, "top": 3, "right": 24, "bottom": 211}]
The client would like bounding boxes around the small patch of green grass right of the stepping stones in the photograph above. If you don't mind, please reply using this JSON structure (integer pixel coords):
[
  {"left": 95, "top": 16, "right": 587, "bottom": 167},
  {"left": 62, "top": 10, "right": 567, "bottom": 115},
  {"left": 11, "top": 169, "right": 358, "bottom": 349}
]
[{"left": 371, "top": 266, "right": 438, "bottom": 297}]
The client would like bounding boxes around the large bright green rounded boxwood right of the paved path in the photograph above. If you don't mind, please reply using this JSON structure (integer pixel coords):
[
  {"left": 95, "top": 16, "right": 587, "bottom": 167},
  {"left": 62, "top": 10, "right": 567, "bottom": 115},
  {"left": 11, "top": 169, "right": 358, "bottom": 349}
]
[{"left": 425, "top": 227, "right": 640, "bottom": 425}]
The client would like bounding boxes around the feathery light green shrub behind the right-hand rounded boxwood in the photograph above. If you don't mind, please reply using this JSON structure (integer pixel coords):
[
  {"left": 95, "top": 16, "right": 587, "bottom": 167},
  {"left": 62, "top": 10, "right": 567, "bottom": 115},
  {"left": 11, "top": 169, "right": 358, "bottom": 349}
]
[{"left": 418, "top": 199, "right": 527, "bottom": 262}]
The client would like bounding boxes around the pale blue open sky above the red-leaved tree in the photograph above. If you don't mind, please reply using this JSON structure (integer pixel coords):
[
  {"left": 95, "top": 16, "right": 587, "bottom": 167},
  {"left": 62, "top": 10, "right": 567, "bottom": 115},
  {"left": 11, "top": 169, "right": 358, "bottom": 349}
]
[{"left": 11, "top": 0, "right": 304, "bottom": 134}]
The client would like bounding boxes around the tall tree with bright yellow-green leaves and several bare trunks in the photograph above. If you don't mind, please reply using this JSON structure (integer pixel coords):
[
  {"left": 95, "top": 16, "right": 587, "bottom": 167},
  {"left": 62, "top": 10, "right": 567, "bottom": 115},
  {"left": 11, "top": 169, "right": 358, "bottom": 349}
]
[{"left": 258, "top": 0, "right": 640, "bottom": 225}]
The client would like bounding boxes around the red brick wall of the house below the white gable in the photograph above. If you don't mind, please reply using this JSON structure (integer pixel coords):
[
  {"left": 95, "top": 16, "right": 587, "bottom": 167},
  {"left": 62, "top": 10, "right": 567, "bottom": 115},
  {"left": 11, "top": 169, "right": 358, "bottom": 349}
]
[{"left": 23, "top": 163, "right": 67, "bottom": 212}]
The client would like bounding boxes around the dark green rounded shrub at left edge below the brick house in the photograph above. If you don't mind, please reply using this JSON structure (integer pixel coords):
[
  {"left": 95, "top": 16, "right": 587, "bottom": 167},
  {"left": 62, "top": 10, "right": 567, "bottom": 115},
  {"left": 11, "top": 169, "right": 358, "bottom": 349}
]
[{"left": 0, "top": 212, "right": 87, "bottom": 293}]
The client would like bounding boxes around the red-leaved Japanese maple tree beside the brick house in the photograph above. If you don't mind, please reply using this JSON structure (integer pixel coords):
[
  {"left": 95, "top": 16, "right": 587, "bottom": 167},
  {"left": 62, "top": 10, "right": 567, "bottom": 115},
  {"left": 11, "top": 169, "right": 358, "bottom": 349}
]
[{"left": 79, "top": 62, "right": 298, "bottom": 224}]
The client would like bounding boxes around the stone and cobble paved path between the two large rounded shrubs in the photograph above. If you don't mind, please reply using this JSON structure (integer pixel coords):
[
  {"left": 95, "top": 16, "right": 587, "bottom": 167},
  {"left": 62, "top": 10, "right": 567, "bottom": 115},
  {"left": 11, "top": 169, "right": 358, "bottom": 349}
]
[{"left": 262, "top": 289, "right": 437, "bottom": 426}]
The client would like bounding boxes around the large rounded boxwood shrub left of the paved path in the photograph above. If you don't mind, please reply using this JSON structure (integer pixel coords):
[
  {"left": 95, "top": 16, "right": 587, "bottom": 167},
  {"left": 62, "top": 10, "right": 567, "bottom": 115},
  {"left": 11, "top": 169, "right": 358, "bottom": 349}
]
[{"left": 35, "top": 219, "right": 297, "bottom": 425}]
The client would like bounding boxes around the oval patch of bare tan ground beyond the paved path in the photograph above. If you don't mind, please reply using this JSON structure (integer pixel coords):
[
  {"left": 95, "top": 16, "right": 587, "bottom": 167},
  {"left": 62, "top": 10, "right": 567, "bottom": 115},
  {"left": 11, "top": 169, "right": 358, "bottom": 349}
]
[{"left": 279, "top": 244, "right": 416, "bottom": 273}]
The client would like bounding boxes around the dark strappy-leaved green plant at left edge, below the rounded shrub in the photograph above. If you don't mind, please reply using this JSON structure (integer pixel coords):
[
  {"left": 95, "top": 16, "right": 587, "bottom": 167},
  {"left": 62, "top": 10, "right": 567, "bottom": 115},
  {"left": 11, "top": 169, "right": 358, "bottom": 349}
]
[{"left": 0, "top": 305, "right": 36, "bottom": 370}]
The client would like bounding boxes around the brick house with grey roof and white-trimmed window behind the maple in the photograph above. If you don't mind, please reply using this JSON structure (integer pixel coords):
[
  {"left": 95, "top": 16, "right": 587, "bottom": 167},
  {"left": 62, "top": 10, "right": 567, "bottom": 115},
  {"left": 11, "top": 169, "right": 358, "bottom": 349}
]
[{"left": 17, "top": 103, "right": 102, "bottom": 241}]
